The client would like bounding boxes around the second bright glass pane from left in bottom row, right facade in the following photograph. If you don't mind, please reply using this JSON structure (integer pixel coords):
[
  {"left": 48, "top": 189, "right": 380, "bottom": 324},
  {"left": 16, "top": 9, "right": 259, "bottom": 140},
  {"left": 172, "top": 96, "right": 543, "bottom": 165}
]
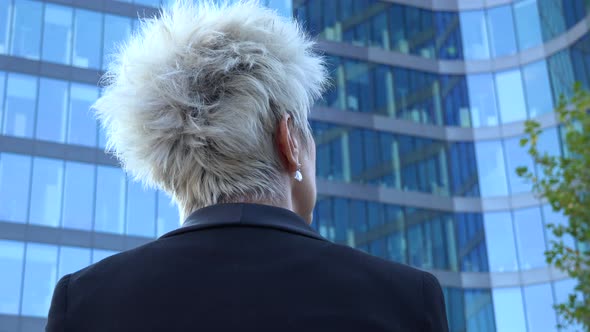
[{"left": 523, "top": 284, "right": 557, "bottom": 332}]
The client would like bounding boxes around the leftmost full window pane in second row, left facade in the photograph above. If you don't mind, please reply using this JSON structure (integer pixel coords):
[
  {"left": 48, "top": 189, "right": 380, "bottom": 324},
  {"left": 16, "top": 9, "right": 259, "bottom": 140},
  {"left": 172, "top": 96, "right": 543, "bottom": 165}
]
[{"left": 2, "top": 73, "right": 37, "bottom": 137}]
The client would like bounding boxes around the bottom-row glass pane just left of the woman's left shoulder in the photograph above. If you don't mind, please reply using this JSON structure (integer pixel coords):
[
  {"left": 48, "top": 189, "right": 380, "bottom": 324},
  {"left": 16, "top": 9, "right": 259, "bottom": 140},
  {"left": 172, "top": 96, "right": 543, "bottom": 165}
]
[{"left": 21, "top": 243, "right": 57, "bottom": 317}]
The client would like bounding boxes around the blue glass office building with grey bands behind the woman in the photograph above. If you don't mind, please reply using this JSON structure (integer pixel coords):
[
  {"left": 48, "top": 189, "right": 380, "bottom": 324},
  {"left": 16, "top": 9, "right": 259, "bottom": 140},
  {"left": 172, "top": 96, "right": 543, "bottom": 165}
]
[{"left": 0, "top": 0, "right": 590, "bottom": 332}]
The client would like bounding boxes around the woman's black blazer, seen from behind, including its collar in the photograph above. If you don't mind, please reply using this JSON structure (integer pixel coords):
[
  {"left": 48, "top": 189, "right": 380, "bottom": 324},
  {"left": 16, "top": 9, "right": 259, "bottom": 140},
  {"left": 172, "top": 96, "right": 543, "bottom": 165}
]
[{"left": 46, "top": 204, "right": 448, "bottom": 332}]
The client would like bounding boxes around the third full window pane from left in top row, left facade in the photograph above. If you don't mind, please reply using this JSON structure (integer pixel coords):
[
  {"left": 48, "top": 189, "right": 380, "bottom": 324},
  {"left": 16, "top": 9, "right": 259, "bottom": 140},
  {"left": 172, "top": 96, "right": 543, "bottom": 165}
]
[{"left": 72, "top": 9, "right": 102, "bottom": 69}]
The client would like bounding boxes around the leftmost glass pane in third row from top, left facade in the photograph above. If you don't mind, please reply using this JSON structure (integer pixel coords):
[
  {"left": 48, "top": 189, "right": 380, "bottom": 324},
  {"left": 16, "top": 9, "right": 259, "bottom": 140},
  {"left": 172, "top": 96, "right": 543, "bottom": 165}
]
[{"left": 0, "top": 153, "right": 31, "bottom": 223}]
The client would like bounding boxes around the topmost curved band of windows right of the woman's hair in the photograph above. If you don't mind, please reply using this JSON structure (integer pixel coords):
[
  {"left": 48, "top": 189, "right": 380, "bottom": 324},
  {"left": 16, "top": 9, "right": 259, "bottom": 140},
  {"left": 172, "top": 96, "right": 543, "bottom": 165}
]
[{"left": 293, "top": 0, "right": 588, "bottom": 60}]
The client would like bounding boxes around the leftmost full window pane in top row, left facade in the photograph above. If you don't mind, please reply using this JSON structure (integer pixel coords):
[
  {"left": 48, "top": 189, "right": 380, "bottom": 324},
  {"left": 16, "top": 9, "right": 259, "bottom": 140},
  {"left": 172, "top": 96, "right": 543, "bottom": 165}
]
[{"left": 10, "top": 0, "right": 43, "bottom": 60}]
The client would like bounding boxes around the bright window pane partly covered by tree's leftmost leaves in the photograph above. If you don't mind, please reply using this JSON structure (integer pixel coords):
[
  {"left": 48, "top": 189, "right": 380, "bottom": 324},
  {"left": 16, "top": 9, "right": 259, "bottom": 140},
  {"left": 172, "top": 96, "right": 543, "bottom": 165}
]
[{"left": 504, "top": 137, "right": 535, "bottom": 194}]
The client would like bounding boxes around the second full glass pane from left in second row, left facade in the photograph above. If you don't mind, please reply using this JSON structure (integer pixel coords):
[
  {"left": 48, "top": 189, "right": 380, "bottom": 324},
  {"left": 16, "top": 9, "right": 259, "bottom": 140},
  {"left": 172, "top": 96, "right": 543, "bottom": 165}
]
[{"left": 35, "top": 78, "right": 69, "bottom": 142}]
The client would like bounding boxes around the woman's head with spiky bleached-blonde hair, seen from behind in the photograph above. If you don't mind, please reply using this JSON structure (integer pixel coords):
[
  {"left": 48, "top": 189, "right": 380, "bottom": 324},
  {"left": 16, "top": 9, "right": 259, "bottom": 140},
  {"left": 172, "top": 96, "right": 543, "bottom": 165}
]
[{"left": 94, "top": 1, "right": 326, "bottom": 221}]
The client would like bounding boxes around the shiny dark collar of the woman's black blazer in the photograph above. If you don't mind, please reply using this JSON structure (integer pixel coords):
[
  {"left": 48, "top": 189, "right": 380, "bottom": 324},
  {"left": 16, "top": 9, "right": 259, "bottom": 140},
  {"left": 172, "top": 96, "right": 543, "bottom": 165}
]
[{"left": 160, "top": 203, "right": 328, "bottom": 241}]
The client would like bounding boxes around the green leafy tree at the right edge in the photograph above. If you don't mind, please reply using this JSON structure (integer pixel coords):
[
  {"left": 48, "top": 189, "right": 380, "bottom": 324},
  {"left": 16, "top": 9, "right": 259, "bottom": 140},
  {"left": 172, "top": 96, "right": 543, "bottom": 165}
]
[{"left": 516, "top": 84, "right": 590, "bottom": 331}]
